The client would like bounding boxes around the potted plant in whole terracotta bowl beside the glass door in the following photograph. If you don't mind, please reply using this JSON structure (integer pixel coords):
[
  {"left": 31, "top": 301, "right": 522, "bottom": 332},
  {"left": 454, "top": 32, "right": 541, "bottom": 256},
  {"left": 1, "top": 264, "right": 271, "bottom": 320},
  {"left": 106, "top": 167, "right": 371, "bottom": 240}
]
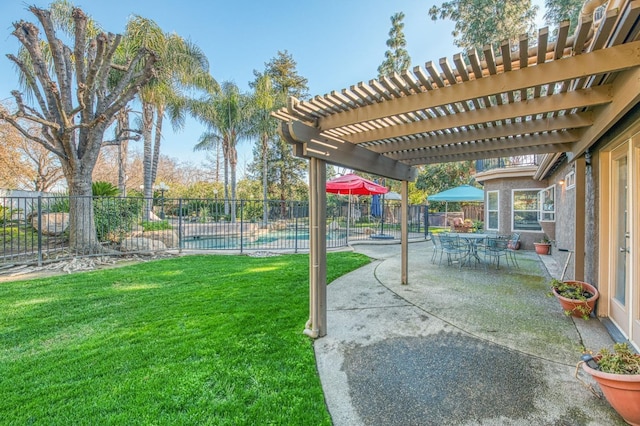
[{"left": 551, "top": 279, "right": 600, "bottom": 319}]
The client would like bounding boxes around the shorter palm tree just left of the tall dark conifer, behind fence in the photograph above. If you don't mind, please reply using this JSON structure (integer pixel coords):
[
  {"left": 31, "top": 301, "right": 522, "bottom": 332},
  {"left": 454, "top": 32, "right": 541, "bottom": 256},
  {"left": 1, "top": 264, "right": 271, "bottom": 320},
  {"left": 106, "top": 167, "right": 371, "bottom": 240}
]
[{"left": 190, "top": 81, "right": 251, "bottom": 222}]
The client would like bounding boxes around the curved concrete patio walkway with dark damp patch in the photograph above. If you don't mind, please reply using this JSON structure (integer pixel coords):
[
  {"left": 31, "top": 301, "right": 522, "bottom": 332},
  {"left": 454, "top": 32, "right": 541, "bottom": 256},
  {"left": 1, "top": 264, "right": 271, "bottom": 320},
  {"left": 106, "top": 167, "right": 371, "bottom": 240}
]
[{"left": 314, "top": 242, "right": 625, "bottom": 426}]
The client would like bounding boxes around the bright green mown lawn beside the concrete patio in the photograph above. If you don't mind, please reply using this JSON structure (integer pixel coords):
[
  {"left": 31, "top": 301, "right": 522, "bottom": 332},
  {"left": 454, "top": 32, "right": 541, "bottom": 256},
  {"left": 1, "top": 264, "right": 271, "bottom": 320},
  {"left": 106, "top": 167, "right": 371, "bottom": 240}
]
[{"left": 0, "top": 253, "right": 368, "bottom": 425}]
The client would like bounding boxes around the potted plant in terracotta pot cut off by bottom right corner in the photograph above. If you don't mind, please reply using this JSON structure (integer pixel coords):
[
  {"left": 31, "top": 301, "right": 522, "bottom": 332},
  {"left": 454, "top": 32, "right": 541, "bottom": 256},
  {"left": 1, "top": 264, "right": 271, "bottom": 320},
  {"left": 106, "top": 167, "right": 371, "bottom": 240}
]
[{"left": 581, "top": 343, "right": 640, "bottom": 425}]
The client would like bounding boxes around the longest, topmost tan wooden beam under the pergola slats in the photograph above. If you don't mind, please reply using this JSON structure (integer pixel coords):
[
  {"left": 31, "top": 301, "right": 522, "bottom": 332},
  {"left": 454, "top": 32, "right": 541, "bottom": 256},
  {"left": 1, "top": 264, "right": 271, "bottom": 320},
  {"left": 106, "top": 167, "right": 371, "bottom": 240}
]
[{"left": 318, "top": 41, "right": 640, "bottom": 130}]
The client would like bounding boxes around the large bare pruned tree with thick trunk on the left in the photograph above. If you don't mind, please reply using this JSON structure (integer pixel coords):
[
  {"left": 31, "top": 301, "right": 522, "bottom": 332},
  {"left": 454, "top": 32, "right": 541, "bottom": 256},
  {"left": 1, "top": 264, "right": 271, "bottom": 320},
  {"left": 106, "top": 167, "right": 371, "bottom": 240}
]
[{"left": 0, "top": 6, "right": 155, "bottom": 252}]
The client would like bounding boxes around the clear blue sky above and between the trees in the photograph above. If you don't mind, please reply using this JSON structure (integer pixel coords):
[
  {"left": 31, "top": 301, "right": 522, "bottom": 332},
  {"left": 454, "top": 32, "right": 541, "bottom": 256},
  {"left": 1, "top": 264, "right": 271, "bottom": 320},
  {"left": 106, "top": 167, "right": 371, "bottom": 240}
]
[{"left": 0, "top": 0, "right": 542, "bottom": 172}]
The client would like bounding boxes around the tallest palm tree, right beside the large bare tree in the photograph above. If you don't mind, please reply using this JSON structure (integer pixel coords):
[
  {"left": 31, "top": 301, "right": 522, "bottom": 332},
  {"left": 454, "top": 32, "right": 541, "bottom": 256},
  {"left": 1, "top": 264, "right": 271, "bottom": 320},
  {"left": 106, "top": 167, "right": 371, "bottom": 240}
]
[{"left": 125, "top": 16, "right": 218, "bottom": 212}]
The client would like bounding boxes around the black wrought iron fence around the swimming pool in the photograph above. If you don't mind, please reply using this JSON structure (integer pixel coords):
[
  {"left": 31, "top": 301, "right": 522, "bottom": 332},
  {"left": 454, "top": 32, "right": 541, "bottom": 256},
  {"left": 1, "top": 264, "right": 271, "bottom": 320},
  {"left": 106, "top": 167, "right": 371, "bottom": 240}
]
[{"left": 0, "top": 196, "right": 426, "bottom": 267}]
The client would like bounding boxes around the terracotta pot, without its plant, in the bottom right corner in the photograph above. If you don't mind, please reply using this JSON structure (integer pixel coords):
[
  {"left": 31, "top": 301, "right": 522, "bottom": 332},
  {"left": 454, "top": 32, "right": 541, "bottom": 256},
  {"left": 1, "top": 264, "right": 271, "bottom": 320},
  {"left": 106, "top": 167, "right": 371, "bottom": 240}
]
[{"left": 582, "top": 357, "right": 640, "bottom": 426}]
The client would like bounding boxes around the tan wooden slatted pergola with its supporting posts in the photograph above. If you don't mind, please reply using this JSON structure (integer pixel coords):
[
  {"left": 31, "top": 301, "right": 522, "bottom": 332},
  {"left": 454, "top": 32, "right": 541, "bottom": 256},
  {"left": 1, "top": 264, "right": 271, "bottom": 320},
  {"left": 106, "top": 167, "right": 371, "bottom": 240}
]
[{"left": 273, "top": 0, "right": 640, "bottom": 337}]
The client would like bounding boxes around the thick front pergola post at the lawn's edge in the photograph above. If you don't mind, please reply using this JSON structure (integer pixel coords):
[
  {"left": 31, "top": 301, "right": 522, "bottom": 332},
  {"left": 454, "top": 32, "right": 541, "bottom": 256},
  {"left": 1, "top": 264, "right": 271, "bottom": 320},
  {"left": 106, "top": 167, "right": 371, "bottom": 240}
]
[{"left": 304, "top": 158, "right": 327, "bottom": 339}]
